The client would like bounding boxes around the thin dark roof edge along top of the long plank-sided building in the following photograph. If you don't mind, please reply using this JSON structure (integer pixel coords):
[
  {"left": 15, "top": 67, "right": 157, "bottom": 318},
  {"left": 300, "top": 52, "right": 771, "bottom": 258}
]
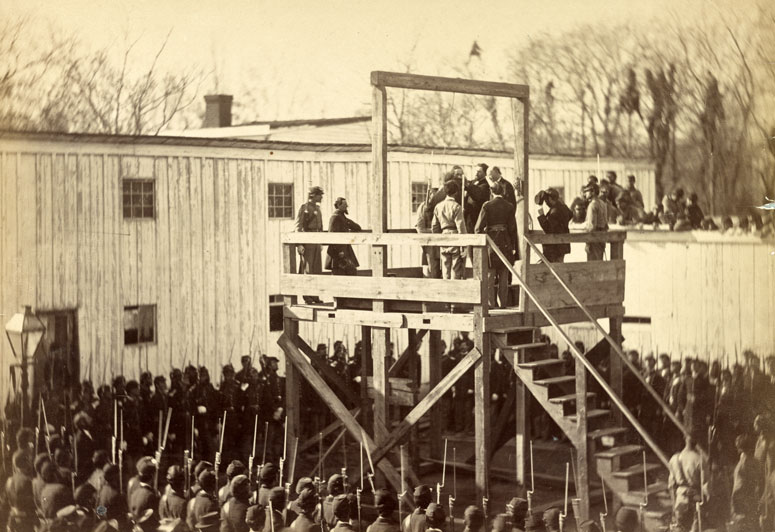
[{"left": 0, "top": 130, "right": 650, "bottom": 164}]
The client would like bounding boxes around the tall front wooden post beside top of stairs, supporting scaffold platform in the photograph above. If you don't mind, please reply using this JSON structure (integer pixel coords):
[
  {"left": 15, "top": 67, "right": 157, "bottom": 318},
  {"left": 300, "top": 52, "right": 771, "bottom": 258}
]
[{"left": 473, "top": 247, "right": 492, "bottom": 501}]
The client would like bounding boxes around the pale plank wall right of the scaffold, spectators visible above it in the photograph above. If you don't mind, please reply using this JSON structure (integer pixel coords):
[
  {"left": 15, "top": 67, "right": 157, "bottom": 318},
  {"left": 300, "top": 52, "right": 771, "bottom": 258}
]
[{"left": 546, "top": 231, "right": 775, "bottom": 363}]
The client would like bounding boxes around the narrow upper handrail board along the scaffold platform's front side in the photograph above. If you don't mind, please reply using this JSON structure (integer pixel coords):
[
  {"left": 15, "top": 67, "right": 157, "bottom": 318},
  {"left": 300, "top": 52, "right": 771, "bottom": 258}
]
[{"left": 282, "top": 232, "right": 488, "bottom": 247}]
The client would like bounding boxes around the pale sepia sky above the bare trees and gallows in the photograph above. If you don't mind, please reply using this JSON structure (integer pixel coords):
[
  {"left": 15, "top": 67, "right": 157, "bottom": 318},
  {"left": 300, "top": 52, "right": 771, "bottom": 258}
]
[{"left": 0, "top": 0, "right": 740, "bottom": 118}]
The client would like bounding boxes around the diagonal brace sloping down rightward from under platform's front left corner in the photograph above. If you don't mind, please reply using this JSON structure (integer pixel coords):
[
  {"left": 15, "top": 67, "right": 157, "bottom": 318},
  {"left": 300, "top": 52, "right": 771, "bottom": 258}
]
[{"left": 277, "top": 333, "right": 414, "bottom": 508}]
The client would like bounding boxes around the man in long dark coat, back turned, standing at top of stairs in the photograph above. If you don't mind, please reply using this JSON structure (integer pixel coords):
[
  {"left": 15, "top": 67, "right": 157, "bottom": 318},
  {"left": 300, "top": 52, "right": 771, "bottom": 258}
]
[{"left": 475, "top": 183, "right": 519, "bottom": 308}]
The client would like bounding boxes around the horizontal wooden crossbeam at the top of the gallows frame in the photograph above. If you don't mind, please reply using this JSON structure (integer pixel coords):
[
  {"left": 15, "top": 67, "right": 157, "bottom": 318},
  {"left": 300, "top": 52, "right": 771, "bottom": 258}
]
[{"left": 371, "top": 70, "right": 530, "bottom": 99}]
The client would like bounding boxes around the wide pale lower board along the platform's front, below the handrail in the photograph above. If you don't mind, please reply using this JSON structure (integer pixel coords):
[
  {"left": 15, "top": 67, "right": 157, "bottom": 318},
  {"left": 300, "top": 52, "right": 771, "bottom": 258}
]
[{"left": 280, "top": 274, "right": 480, "bottom": 304}]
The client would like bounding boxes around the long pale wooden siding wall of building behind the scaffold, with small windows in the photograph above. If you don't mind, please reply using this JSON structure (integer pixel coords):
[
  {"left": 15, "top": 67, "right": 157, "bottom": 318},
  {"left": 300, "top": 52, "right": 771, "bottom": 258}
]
[{"left": 0, "top": 136, "right": 653, "bottom": 400}]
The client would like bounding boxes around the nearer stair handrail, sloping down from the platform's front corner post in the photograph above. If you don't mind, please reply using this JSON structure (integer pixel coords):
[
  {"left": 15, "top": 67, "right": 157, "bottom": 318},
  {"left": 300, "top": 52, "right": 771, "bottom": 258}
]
[{"left": 487, "top": 235, "right": 670, "bottom": 468}]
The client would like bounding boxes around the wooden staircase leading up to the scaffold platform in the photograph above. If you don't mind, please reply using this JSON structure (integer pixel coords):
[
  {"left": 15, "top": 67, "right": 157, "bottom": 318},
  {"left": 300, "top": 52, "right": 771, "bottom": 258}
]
[{"left": 495, "top": 327, "right": 672, "bottom": 531}]
